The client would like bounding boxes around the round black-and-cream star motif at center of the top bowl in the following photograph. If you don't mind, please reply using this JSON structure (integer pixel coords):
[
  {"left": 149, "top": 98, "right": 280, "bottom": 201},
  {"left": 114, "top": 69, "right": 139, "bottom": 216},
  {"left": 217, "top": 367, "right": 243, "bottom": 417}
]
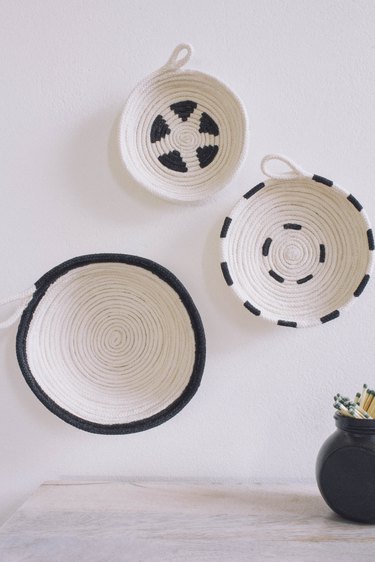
[{"left": 150, "top": 100, "right": 220, "bottom": 173}]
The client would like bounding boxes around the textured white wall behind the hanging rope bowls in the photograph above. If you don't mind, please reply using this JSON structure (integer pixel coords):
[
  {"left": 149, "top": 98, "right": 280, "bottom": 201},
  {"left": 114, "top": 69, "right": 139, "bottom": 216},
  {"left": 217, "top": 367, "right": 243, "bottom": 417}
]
[{"left": 0, "top": 0, "right": 375, "bottom": 519}]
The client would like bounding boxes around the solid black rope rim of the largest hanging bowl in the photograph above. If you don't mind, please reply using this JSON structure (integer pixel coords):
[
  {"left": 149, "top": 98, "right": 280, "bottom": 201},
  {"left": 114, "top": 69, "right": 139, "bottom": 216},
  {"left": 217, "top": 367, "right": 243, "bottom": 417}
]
[{"left": 16, "top": 254, "right": 206, "bottom": 434}]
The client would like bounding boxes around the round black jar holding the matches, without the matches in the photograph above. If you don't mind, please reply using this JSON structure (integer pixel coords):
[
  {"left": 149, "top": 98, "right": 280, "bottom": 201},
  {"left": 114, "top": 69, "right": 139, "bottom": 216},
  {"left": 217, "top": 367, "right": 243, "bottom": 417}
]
[{"left": 316, "top": 414, "right": 375, "bottom": 523}]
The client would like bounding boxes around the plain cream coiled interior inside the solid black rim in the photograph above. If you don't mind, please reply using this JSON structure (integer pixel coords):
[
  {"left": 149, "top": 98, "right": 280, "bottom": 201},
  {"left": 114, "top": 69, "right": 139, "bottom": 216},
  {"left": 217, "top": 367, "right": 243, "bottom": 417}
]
[{"left": 26, "top": 263, "right": 195, "bottom": 424}]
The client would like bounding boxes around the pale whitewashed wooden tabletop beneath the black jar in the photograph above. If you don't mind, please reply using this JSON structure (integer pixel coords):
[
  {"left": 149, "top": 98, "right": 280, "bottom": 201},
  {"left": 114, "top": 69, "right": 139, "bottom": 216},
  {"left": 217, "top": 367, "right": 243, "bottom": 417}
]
[{"left": 0, "top": 480, "right": 375, "bottom": 562}]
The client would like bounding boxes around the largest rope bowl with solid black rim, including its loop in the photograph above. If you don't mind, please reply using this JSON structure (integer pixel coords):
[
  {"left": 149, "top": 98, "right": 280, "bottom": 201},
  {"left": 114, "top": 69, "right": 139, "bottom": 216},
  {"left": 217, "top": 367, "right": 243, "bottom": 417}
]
[{"left": 0, "top": 254, "right": 205, "bottom": 434}]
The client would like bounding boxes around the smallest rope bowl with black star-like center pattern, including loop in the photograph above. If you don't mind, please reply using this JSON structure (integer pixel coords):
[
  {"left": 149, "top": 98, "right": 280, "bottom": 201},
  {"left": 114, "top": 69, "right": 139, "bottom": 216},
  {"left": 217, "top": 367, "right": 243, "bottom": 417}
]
[{"left": 119, "top": 44, "right": 247, "bottom": 202}]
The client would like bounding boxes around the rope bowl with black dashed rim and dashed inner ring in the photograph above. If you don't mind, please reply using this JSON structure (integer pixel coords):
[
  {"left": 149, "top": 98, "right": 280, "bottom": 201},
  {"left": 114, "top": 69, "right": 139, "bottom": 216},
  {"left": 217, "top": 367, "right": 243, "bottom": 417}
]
[{"left": 220, "top": 155, "right": 374, "bottom": 328}]
